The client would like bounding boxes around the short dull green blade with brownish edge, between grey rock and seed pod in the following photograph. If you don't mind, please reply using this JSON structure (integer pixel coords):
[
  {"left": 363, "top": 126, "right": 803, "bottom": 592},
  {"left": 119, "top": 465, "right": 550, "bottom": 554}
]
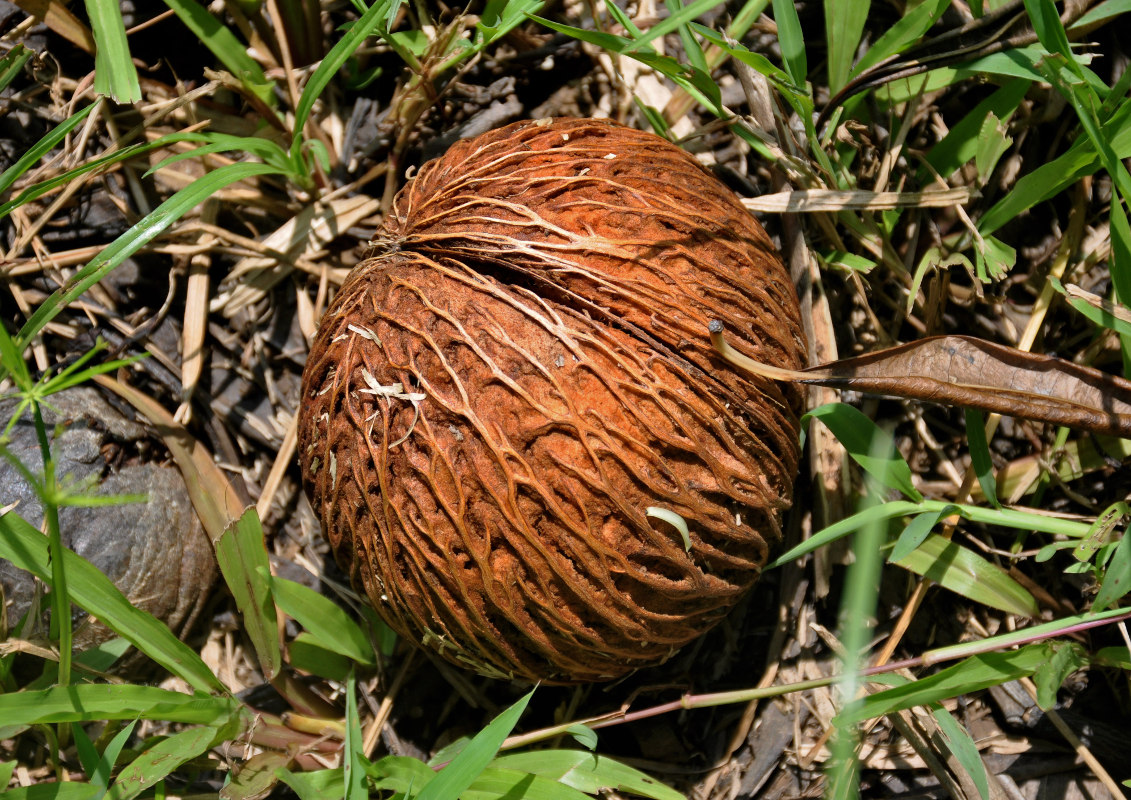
[{"left": 215, "top": 506, "right": 283, "bottom": 680}]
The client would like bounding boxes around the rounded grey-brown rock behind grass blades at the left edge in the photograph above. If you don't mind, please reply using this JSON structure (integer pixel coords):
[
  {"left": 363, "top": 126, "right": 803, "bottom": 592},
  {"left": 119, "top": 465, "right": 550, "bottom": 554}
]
[{"left": 0, "top": 387, "right": 217, "bottom": 670}]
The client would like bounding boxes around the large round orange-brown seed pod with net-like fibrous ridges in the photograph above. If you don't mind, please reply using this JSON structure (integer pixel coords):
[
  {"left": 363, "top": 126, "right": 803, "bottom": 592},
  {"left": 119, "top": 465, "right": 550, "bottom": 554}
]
[{"left": 300, "top": 121, "right": 802, "bottom": 682}]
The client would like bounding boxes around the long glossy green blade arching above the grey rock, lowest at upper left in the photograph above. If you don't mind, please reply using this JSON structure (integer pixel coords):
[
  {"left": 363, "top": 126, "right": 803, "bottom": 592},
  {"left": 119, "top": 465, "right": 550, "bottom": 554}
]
[{"left": 16, "top": 163, "right": 278, "bottom": 351}]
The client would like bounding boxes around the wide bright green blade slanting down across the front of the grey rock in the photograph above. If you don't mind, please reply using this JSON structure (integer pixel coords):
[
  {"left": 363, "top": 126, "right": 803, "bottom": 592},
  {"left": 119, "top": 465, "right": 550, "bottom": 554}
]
[{"left": 0, "top": 513, "right": 225, "bottom": 692}]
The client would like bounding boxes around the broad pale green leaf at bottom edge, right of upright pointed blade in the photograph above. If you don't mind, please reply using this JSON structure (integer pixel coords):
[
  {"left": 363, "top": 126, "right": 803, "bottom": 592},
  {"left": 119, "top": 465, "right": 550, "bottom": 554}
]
[{"left": 491, "top": 750, "right": 683, "bottom": 800}]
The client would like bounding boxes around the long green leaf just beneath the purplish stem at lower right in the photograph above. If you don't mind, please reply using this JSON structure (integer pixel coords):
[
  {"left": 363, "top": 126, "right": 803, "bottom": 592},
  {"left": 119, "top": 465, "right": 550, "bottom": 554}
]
[{"left": 841, "top": 645, "right": 1052, "bottom": 724}]
